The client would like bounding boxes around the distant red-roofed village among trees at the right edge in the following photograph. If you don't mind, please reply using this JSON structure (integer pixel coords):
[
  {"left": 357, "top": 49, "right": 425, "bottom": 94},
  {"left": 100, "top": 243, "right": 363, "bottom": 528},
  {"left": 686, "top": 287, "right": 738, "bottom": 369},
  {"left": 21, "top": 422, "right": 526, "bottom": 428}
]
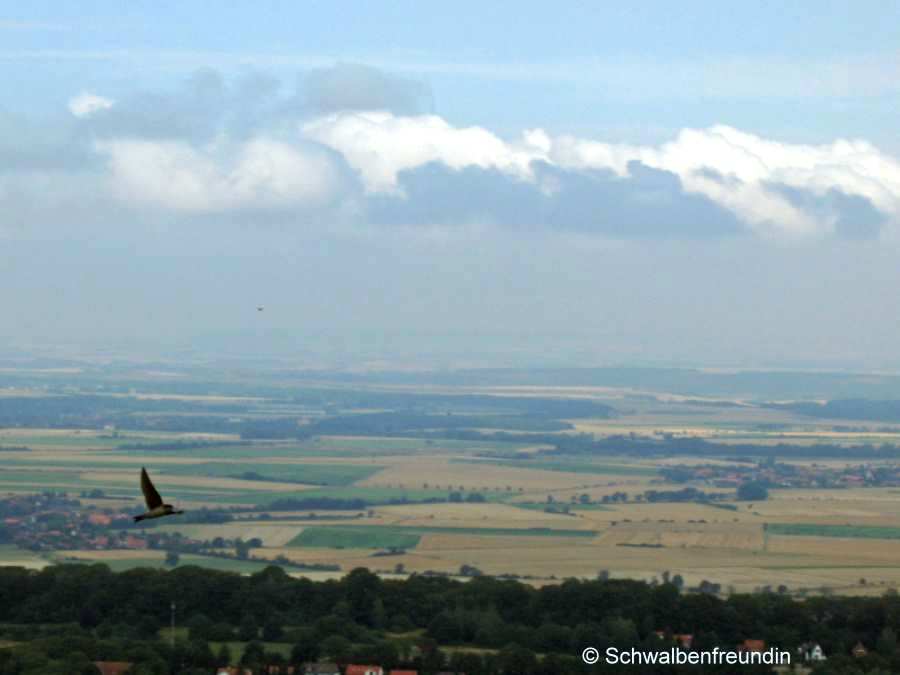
[{"left": 661, "top": 462, "right": 900, "bottom": 488}]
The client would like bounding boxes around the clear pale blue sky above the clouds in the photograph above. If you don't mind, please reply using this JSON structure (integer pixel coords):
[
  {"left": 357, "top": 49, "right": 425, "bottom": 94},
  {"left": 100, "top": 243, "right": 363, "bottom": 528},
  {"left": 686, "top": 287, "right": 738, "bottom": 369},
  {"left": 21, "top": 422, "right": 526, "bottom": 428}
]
[{"left": 0, "top": 2, "right": 900, "bottom": 144}]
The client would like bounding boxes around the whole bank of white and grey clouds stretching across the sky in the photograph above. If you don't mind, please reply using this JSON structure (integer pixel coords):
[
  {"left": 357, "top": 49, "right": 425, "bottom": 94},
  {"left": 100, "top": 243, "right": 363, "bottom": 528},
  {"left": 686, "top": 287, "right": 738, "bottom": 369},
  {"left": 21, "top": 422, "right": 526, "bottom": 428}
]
[{"left": 0, "top": 64, "right": 900, "bottom": 241}]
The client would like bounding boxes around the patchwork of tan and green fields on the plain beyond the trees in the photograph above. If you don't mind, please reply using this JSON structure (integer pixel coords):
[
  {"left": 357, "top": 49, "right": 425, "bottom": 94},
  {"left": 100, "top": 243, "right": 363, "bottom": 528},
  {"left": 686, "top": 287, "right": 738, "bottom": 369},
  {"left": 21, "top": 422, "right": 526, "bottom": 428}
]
[{"left": 8, "top": 384, "right": 900, "bottom": 604}]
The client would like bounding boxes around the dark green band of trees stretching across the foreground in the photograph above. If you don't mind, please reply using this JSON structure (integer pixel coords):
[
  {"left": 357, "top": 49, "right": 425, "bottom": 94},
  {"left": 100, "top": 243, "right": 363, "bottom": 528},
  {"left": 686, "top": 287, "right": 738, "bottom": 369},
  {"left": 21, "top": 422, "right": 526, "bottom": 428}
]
[{"left": 0, "top": 565, "right": 900, "bottom": 675}]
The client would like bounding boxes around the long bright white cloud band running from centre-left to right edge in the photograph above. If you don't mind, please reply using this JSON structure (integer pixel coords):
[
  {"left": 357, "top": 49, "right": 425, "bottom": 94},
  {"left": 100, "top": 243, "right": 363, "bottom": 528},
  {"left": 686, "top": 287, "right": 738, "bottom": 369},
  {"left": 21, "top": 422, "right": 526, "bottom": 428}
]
[{"left": 301, "top": 112, "right": 900, "bottom": 243}]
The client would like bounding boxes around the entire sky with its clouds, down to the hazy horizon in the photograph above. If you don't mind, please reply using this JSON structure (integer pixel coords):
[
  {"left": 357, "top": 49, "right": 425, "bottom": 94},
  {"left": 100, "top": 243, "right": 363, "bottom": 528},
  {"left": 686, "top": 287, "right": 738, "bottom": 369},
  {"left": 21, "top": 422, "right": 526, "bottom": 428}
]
[{"left": 0, "top": 1, "right": 900, "bottom": 370}]
